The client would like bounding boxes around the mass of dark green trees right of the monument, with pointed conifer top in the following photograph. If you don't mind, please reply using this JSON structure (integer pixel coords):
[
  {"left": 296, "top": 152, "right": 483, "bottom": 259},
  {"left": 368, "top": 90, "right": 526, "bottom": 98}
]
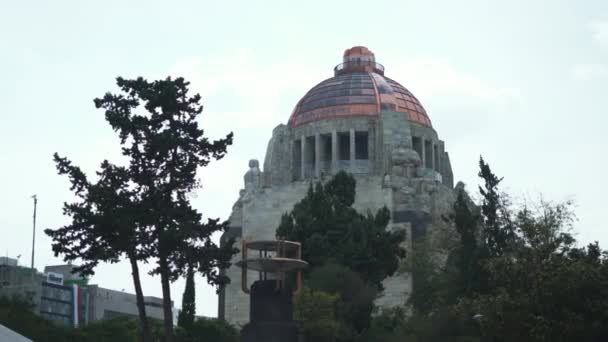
[{"left": 368, "top": 159, "right": 608, "bottom": 342}]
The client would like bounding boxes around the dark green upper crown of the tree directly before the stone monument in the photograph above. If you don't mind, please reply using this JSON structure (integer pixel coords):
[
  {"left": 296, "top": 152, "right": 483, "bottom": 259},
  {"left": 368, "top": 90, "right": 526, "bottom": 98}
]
[{"left": 277, "top": 171, "right": 405, "bottom": 288}]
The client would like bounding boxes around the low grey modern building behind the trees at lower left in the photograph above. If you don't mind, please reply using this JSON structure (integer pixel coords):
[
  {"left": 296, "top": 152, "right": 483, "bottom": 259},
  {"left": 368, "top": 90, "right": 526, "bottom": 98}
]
[{"left": 0, "top": 264, "right": 169, "bottom": 327}]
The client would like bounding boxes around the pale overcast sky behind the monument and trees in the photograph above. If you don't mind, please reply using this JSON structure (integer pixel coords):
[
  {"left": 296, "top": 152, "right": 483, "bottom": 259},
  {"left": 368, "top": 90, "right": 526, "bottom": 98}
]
[{"left": 0, "top": 0, "right": 608, "bottom": 316}]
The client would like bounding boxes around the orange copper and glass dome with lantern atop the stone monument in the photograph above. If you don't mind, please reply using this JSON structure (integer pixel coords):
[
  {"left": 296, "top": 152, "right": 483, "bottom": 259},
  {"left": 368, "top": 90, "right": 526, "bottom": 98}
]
[{"left": 289, "top": 46, "right": 432, "bottom": 127}]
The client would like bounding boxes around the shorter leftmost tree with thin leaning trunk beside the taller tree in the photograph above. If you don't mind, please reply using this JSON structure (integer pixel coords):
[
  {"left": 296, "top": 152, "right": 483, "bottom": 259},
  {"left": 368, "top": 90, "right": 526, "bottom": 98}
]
[{"left": 45, "top": 153, "right": 152, "bottom": 341}]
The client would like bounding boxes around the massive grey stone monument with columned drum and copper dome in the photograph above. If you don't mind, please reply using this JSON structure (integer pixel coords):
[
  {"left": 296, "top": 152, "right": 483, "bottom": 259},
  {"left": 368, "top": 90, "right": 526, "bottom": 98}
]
[{"left": 218, "top": 46, "right": 454, "bottom": 325}]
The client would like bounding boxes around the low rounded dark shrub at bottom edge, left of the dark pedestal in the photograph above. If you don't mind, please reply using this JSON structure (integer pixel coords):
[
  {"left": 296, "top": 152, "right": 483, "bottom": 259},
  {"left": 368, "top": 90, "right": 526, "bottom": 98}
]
[{"left": 176, "top": 318, "right": 241, "bottom": 342}]
